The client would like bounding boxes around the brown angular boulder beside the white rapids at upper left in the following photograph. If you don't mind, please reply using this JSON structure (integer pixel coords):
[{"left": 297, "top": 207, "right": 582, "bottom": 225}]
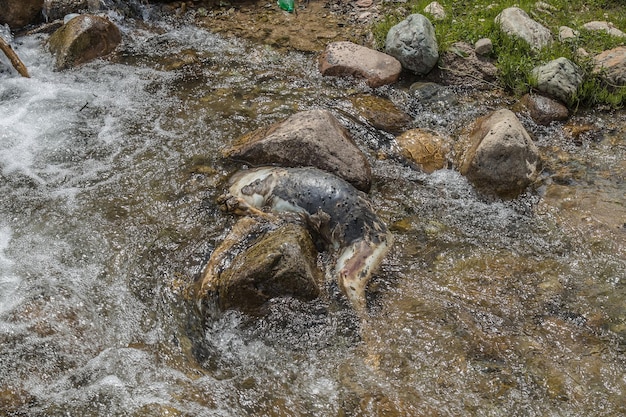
[{"left": 49, "top": 15, "right": 122, "bottom": 70}]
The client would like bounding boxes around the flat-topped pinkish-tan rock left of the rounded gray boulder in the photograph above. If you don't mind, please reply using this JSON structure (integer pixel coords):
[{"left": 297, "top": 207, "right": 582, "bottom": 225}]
[{"left": 319, "top": 41, "right": 402, "bottom": 87}]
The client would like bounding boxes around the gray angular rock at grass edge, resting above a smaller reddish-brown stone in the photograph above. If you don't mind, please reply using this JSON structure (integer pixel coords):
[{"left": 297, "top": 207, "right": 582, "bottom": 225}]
[{"left": 532, "top": 57, "right": 583, "bottom": 103}]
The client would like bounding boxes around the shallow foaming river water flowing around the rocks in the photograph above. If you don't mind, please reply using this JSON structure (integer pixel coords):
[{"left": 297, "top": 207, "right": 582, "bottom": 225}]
[{"left": 0, "top": 7, "right": 626, "bottom": 417}]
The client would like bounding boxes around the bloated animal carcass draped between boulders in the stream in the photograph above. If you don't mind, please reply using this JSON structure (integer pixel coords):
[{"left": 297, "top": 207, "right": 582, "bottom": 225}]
[{"left": 214, "top": 167, "right": 392, "bottom": 311}]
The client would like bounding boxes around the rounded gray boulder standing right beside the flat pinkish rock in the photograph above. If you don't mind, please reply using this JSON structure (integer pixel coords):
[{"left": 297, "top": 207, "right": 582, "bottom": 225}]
[{"left": 385, "top": 14, "right": 439, "bottom": 75}]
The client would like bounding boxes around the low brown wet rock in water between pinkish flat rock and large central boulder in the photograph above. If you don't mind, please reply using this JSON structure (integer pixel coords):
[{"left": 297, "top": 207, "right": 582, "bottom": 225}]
[{"left": 350, "top": 95, "right": 411, "bottom": 134}]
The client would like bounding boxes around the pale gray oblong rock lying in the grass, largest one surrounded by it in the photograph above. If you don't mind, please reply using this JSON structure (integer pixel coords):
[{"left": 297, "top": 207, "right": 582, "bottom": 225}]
[{"left": 495, "top": 7, "right": 552, "bottom": 49}]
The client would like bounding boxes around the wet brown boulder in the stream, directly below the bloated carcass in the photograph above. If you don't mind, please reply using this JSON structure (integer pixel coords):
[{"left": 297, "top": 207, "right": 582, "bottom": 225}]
[{"left": 198, "top": 217, "right": 324, "bottom": 314}]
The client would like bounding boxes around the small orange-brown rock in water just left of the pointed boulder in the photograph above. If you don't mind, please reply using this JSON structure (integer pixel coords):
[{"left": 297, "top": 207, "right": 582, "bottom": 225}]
[{"left": 396, "top": 129, "right": 450, "bottom": 174}]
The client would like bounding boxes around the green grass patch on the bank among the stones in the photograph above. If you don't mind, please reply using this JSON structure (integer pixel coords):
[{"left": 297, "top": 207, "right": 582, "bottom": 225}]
[{"left": 373, "top": 0, "right": 626, "bottom": 109}]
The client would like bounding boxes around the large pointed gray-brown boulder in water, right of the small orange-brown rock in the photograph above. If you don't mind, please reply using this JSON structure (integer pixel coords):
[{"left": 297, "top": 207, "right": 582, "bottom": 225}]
[{"left": 459, "top": 109, "right": 540, "bottom": 198}]
